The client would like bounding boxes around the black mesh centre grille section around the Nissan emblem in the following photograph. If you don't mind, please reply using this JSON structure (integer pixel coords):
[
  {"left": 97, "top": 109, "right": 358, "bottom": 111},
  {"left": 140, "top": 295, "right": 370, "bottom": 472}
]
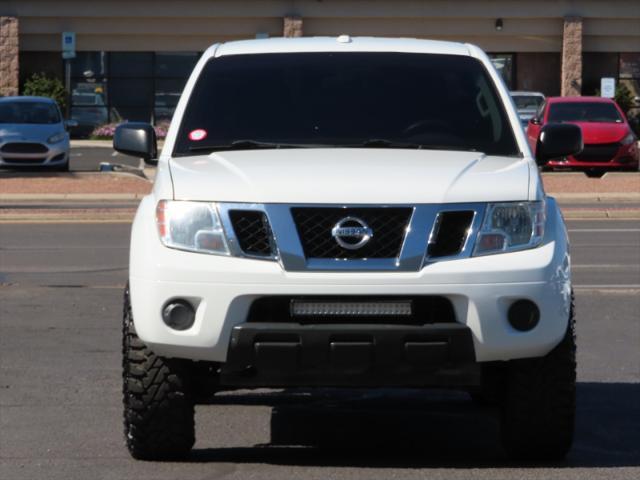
[{"left": 291, "top": 207, "right": 412, "bottom": 259}]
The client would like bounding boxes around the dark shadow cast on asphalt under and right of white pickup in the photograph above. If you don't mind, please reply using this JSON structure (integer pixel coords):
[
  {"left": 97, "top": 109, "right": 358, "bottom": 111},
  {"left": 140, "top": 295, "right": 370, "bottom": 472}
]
[{"left": 191, "top": 383, "right": 640, "bottom": 468}]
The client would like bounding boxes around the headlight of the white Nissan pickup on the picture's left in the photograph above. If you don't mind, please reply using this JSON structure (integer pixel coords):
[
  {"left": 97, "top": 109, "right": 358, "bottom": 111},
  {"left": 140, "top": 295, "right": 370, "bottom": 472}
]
[{"left": 156, "top": 200, "right": 229, "bottom": 255}]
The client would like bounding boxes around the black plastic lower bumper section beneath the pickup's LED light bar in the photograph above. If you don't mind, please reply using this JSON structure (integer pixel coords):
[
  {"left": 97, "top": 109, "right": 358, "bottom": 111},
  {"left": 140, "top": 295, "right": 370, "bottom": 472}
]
[{"left": 220, "top": 323, "right": 481, "bottom": 387}]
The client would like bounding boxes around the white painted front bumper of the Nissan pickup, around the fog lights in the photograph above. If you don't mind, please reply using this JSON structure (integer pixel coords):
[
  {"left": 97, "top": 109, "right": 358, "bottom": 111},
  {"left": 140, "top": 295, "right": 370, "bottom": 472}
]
[{"left": 130, "top": 197, "right": 571, "bottom": 362}]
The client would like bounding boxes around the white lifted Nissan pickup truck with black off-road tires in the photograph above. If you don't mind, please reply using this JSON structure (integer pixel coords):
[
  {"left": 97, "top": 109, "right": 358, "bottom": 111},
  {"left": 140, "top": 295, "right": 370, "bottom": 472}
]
[{"left": 114, "top": 36, "right": 582, "bottom": 459}]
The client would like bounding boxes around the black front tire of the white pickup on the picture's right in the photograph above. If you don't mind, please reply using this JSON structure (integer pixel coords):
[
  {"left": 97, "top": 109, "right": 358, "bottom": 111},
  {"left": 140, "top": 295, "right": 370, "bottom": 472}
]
[{"left": 501, "top": 298, "right": 576, "bottom": 461}]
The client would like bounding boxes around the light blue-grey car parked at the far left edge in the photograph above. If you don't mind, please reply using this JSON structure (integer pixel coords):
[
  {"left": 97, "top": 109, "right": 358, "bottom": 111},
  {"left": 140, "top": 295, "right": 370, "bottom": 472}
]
[{"left": 0, "top": 97, "right": 75, "bottom": 171}]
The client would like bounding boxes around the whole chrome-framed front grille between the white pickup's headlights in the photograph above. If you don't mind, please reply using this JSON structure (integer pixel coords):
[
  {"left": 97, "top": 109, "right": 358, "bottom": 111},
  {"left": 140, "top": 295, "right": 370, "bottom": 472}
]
[{"left": 218, "top": 203, "right": 485, "bottom": 272}]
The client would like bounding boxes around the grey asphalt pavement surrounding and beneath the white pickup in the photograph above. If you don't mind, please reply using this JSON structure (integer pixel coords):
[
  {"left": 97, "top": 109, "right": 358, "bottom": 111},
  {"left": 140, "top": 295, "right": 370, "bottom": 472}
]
[{"left": 0, "top": 220, "right": 640, "bottom": 480}]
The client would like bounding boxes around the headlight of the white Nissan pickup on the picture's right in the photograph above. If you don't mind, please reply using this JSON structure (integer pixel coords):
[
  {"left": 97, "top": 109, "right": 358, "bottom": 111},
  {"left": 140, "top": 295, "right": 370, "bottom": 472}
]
[{"left": 473, "top": 202, "right": 546, "bottom": 255}]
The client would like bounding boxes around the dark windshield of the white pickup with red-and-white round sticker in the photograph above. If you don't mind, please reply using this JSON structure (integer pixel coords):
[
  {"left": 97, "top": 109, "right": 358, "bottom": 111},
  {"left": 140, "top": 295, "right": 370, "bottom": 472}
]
[{"left": 174, "top": 52, "right": 519, "bottom": 156}]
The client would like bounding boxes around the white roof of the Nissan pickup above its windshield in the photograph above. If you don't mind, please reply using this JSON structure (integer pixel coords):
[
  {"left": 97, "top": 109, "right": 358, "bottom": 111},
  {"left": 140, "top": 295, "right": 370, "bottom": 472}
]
[{"left": 205, "top": 35, "right": 471, "bottom": 57}]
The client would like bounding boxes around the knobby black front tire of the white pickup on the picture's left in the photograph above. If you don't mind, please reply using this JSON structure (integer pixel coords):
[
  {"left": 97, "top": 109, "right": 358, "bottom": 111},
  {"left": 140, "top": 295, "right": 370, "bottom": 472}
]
[{"left": 122, "top": 286, "right": 195, "bottom": 460}]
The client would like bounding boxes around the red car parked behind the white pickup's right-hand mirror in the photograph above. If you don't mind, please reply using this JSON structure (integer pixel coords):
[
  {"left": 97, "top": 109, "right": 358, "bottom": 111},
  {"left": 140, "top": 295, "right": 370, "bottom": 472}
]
[{"left": 527, "top": 97, "right": 640, "bottom": 170}]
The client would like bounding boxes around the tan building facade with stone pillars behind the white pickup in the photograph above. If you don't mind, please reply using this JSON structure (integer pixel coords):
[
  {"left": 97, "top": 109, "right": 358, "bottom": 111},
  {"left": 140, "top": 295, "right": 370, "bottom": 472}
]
[{"left": 0, "top": 0, "right": 640, "bottom": 131}]
